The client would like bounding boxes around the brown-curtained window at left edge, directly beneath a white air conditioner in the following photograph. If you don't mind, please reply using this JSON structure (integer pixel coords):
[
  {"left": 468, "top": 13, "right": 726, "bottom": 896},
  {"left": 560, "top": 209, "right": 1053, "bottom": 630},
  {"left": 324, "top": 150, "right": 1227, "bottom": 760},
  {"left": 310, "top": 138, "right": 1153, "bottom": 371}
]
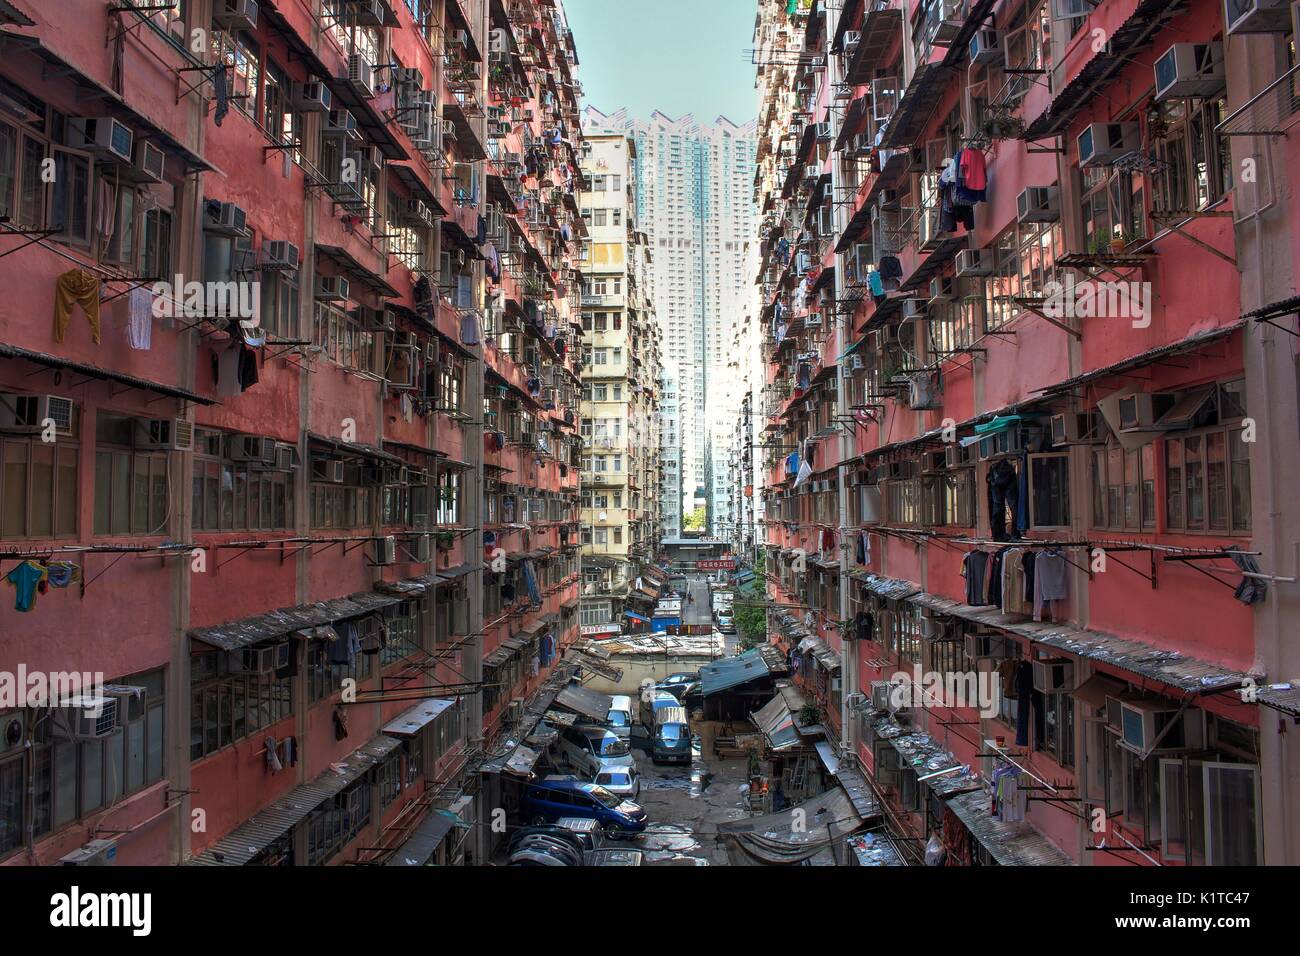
[{"left": 0, "top": 436, "right": 79, "bottom": 541}]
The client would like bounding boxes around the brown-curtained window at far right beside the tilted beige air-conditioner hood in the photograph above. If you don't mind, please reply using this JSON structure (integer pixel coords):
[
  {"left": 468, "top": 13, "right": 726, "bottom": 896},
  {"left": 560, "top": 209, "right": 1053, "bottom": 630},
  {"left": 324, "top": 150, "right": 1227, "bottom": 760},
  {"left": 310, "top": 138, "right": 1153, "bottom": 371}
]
[{"left": 1165, "top": 378, "right": 1251, "bottom": 535}]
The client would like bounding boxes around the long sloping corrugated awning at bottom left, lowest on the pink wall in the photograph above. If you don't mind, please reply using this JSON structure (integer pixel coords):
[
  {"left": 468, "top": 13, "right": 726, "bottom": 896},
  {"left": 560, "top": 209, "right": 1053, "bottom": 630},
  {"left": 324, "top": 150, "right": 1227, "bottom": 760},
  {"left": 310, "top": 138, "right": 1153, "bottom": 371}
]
[{"left": 190, "top": 735, "right": 400, "bottom": 866}]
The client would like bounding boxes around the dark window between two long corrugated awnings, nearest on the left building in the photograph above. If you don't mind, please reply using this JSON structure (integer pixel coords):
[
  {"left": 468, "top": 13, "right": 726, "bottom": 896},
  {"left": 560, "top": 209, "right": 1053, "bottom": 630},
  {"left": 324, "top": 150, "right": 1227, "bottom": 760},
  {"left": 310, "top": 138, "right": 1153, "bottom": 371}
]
[{"left": 190, "top": 650, "right": 294, "bottom": 761}]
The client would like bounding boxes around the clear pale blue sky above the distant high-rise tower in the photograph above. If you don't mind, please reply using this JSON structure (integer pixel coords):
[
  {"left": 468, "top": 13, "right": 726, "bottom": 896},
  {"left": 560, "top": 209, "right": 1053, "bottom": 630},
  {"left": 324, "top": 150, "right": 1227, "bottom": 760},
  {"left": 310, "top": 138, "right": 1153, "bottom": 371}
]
[{"left": 564, "top": 0, "right": 758, "bottom": 124}]
